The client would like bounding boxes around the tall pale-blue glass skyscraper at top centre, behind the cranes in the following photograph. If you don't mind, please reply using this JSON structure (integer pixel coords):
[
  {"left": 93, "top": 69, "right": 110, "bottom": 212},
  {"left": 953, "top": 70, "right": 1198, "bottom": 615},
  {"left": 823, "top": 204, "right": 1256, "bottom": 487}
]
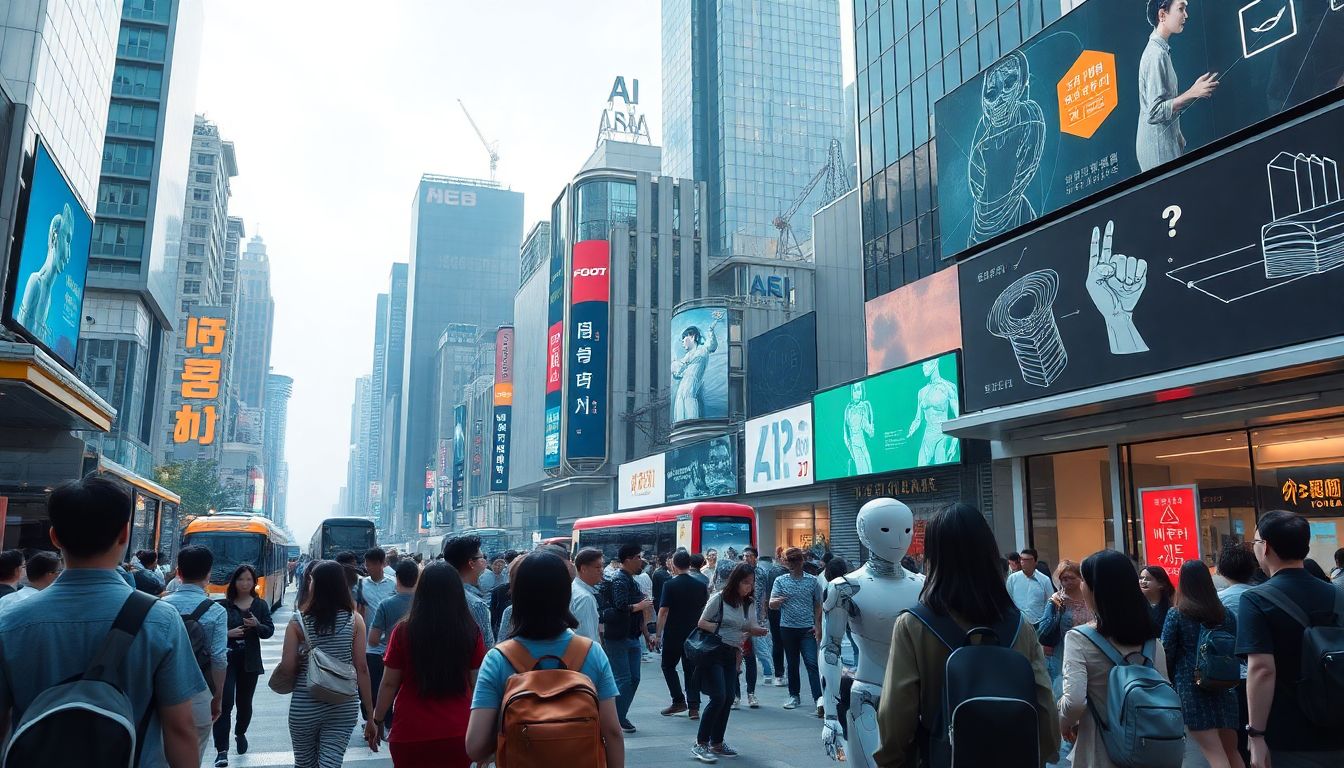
[{"left": 663, "top": 0, "right": 844, "bottom": 257}]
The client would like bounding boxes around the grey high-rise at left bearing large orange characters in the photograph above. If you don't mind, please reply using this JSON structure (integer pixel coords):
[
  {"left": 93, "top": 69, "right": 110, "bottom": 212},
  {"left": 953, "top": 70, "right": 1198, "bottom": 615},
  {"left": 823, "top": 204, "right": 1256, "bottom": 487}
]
[{"left": 160, "top": 114, "right": 242, "bottom": 463}]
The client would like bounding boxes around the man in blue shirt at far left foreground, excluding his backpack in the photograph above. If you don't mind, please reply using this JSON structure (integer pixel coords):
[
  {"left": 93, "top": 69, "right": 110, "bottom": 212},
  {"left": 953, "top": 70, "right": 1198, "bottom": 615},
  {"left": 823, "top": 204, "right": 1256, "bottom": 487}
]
[{"left": 0, "top": 476, "right": 206, "bottom": 768}]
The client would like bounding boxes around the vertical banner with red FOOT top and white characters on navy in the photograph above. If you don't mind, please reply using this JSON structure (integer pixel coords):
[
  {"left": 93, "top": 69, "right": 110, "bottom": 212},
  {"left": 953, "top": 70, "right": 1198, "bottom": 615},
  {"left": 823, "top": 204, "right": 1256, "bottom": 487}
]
[{"left": 564, "top": 239, "right": 612, "bottom": 460}]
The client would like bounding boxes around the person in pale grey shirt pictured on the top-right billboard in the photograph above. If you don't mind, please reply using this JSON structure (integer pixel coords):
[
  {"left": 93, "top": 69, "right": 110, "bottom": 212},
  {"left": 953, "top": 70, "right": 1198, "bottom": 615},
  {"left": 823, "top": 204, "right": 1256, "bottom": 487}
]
[{"left": 1134, "top": 0, "right": 1218, "bottom": 171}]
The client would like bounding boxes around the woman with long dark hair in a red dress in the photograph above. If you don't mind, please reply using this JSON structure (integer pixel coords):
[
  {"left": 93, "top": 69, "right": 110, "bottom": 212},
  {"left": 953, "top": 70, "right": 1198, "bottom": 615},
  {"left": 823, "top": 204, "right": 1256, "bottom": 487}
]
[{"left": 364, "top": 562, "right": 485, "bottom": 768}]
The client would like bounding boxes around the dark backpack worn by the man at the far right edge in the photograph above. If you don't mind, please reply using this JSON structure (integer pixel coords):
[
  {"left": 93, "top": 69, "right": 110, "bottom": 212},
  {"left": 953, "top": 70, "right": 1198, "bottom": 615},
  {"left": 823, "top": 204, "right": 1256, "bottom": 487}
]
[{"left": 1253, "top": 584, "right": 1344, "bottom": 729}]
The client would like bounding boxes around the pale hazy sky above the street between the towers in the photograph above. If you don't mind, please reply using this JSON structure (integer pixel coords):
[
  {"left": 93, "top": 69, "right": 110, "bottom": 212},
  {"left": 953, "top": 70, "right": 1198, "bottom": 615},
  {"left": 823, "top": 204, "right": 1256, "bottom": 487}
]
[{"left": 198, "top": 0, "right": 853, "bottom": 542}]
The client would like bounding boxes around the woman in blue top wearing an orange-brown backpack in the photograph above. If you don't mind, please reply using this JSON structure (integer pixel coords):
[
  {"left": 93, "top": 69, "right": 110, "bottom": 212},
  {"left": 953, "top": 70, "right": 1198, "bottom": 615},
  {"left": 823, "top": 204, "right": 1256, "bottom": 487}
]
[{"left": 467, "top": 550, "right": 625, "bottom": 768}]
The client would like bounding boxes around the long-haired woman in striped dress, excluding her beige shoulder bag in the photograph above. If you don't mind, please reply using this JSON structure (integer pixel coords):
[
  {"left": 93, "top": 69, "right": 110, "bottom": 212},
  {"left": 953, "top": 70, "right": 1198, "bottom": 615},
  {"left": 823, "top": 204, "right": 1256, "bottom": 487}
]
[{"left": 280, "top": 561, "right": 374, "bottom": 768}]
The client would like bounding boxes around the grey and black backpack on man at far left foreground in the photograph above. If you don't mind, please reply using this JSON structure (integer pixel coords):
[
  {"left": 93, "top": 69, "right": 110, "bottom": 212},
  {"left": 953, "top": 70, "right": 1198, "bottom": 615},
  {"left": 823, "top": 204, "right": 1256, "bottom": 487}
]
[{"left": 3, "top": 592, "right": 157, "bottom": 768}]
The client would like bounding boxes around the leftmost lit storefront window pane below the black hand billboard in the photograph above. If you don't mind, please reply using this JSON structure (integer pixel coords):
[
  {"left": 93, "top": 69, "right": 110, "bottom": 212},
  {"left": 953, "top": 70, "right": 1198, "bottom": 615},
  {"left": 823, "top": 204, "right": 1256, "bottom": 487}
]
[{"left": 1027, "top": 448, "right": 1116, "bottom": 569}]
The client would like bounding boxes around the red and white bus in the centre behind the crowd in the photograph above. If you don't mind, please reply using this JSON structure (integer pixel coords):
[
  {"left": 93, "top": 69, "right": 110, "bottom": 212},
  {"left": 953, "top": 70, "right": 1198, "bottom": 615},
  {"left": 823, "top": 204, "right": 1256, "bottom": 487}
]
[{"left": 573, "top": 502, "right": 757, "bottom": 560}]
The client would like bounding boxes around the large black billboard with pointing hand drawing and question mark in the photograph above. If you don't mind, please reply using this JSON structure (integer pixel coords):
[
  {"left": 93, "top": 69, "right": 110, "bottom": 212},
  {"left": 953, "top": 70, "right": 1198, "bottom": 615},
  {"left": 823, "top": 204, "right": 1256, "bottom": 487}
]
[{"left": 960, "top": 103, "right": 1344, "bottom": 410}]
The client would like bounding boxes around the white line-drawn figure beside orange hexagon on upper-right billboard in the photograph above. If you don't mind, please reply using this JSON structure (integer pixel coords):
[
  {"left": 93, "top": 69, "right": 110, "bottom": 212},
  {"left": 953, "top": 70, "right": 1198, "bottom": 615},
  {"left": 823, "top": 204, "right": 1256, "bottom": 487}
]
[{"left": 966, "top": 51, "right": 1046, "bottom": 245}]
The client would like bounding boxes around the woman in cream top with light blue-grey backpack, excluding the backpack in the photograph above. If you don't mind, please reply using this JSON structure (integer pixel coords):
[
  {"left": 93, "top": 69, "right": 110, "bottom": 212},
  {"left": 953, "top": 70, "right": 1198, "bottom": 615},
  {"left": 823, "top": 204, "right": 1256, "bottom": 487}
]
[{"left": 1059, "top": 549, "right": 1179, "bottom": 768}]
